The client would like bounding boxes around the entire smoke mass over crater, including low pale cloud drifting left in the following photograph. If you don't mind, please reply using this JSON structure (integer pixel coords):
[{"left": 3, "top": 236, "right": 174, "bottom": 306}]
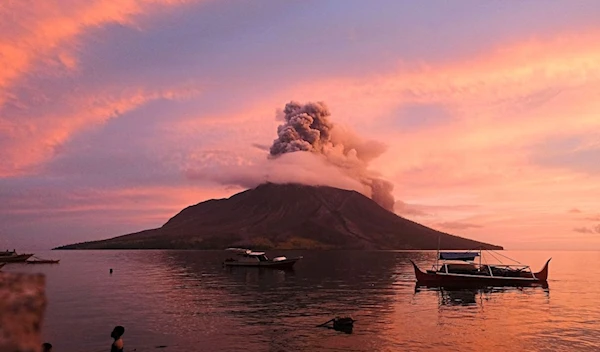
[{"left": 185, "top": 102, "right": 395, "bottom": 212}]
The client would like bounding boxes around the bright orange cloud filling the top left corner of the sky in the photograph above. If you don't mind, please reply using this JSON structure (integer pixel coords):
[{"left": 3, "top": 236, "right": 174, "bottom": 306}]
[{"left": 0, "top": 0, "right": 198, "bottom": 106}]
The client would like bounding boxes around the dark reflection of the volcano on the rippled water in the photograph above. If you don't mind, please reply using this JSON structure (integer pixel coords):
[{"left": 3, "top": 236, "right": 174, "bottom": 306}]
[{"left": 152, "top": 251, "right": 404, "bottom": 351}]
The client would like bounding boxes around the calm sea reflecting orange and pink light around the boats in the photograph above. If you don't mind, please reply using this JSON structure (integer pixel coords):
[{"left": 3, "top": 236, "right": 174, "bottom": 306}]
[{"left": 4, "top": 251, "right": 600, "bottom": 352}]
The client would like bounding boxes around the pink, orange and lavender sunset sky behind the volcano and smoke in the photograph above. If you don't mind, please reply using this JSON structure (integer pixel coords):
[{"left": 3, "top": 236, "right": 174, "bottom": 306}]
[{"left": 0, "top": 0, "right": 600, "bottom": 250}]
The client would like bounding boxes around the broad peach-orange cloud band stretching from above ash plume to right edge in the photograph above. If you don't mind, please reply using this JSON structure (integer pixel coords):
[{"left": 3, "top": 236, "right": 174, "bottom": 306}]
[{"left": 268, "top": 32, "right": 600, "bottom": 123}]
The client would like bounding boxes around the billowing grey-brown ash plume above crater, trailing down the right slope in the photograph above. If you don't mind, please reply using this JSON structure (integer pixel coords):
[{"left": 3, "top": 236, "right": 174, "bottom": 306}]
[{"left": 269, "top": 101, "right": 395, "bottom": 211}]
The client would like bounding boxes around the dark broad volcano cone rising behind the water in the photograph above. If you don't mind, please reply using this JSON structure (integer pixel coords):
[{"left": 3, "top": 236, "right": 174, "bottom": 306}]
[{"left": 58, "top": 183, "right": 502, "bottom": 249}]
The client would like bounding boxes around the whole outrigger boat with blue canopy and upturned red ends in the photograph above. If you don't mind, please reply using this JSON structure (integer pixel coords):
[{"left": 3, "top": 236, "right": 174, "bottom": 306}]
[{"left": 411, "top": 250, "right": 552, "bottom": 287}]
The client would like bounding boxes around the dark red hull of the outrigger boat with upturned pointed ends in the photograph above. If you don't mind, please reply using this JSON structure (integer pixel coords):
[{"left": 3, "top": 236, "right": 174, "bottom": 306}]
[{"left": 411, "top": 260, "right": 550, "bottom": 287}]
